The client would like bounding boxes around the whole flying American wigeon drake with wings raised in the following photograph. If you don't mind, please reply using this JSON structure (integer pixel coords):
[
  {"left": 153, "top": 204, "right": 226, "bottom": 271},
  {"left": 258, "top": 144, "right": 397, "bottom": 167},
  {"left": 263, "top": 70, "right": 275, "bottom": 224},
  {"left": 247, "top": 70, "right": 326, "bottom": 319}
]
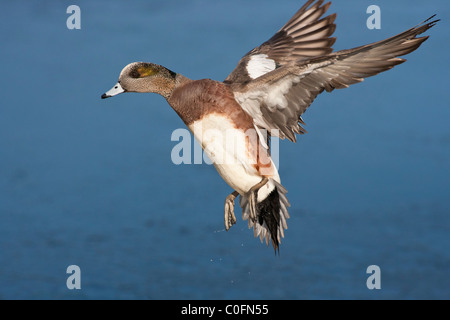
[{"left": 102, "top": 0, "right": 438, "bottom": 252}]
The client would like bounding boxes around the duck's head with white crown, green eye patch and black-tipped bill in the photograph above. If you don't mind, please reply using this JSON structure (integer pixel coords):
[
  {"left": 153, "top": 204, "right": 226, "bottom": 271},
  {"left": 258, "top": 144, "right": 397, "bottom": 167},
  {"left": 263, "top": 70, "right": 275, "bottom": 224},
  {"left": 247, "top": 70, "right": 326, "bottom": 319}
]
[{"left": 102, "top": 62, "right": 177, "bottom": 99}]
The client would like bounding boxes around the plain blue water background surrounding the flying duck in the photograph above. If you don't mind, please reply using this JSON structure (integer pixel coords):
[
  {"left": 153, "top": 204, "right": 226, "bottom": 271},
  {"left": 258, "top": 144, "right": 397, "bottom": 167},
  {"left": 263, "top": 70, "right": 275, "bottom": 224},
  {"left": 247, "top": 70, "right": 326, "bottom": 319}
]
[{"left": 0, "top": 0, "right": 450, "bottom": 299}]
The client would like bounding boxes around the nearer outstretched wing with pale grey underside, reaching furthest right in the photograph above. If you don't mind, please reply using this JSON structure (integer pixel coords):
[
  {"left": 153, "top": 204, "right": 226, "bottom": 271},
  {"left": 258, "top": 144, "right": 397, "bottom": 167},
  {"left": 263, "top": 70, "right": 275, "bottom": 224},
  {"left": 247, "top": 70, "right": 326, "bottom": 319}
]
[{"left": 230, "top": 16, "right": 439, "bottom": 142}]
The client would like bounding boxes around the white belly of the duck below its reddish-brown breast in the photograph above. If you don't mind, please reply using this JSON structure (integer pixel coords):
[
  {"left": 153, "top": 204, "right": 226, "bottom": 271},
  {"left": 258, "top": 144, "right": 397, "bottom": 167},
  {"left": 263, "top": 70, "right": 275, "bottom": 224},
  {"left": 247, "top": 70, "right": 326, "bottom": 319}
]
[{"left": 185, "top": 114, "right": 280, "bottom": 199}]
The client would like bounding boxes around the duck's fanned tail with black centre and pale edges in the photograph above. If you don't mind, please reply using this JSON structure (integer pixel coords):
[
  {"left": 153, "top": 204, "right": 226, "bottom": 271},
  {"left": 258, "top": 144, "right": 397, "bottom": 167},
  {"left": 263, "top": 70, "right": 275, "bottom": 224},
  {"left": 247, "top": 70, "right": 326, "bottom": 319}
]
[{"left": 239, "top": 179, "right": 290, "bottom": 254}]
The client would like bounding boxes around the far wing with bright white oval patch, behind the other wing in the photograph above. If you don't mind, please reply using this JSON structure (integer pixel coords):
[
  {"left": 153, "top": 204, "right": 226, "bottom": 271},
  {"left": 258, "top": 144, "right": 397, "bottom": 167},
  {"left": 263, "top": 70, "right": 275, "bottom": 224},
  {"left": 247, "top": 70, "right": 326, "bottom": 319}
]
[{"left": 224, "top": 0, "right": 336, "bottom": 83}]
